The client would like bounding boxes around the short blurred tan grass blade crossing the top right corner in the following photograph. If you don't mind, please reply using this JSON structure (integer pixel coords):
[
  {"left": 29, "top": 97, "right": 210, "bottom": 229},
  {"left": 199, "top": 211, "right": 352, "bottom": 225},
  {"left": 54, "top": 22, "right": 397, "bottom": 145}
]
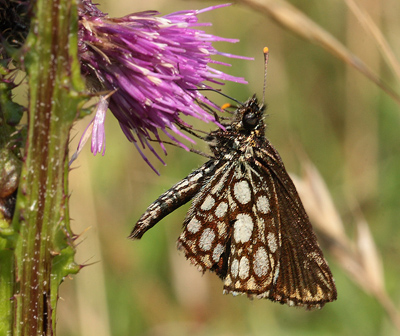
[{"left": 345, "top": 0, "right": 400, "bottom": 79}]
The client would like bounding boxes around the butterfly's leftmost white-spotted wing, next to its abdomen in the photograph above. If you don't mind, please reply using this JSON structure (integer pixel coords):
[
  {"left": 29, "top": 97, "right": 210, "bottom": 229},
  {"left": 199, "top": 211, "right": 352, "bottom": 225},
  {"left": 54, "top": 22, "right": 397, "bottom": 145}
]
[{"left": 177, "top": 162, "right": 234, "bottom": 278}]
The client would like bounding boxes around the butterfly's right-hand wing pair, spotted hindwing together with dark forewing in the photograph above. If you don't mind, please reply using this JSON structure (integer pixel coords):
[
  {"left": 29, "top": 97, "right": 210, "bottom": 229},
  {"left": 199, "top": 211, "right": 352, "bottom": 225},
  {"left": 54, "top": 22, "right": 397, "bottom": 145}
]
[{"left": 224, "top": 158, "right": 336, "bottom": 309}]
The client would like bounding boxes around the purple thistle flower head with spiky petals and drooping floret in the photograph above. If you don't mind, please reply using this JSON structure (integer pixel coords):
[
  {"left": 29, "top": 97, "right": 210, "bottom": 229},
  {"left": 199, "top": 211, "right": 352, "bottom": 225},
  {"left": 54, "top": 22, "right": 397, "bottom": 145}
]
[{"left": 76, "top": 0, "right": 249, "bottom": 170}]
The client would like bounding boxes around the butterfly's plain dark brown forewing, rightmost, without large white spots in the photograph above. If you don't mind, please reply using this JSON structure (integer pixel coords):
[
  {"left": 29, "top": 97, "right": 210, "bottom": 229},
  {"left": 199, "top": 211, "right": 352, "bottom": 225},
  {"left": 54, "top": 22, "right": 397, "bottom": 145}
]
[{"left": 255, "top": 143, "right": 337, "bottom": 308}]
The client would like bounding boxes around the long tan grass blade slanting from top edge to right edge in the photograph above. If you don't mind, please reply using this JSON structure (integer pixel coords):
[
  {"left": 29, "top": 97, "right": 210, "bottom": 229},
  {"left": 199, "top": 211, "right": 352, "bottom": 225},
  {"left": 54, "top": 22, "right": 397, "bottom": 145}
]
[{"left": 238, "top": 0, "right": 400, "bottom": 104}]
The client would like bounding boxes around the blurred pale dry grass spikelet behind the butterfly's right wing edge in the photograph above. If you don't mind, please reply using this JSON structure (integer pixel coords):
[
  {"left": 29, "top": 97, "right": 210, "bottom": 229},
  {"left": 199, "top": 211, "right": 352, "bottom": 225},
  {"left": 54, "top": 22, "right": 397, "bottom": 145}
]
[{"left": 292, "top": 162, "right": 400, "bottom": 330}]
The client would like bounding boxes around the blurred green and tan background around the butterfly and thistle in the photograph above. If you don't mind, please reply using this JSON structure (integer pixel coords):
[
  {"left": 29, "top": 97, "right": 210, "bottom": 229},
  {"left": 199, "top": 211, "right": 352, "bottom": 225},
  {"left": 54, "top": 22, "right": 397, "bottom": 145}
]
[{"left": 58, "top": 0, "right": 400, "bottom": 336}]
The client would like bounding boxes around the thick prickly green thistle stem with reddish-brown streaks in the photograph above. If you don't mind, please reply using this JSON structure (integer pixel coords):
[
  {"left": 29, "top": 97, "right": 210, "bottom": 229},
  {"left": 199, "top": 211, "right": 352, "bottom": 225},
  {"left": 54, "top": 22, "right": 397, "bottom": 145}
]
[{"left": 10, "top": 0, "right": 84, "bottom": 336}]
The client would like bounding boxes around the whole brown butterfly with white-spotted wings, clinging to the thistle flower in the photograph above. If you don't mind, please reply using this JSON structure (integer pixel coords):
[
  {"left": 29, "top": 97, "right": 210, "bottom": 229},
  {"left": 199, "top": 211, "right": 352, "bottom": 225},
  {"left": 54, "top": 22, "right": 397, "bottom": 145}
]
[{"left": 129, "top": 48, "right": 337, "bottom": 309}]
